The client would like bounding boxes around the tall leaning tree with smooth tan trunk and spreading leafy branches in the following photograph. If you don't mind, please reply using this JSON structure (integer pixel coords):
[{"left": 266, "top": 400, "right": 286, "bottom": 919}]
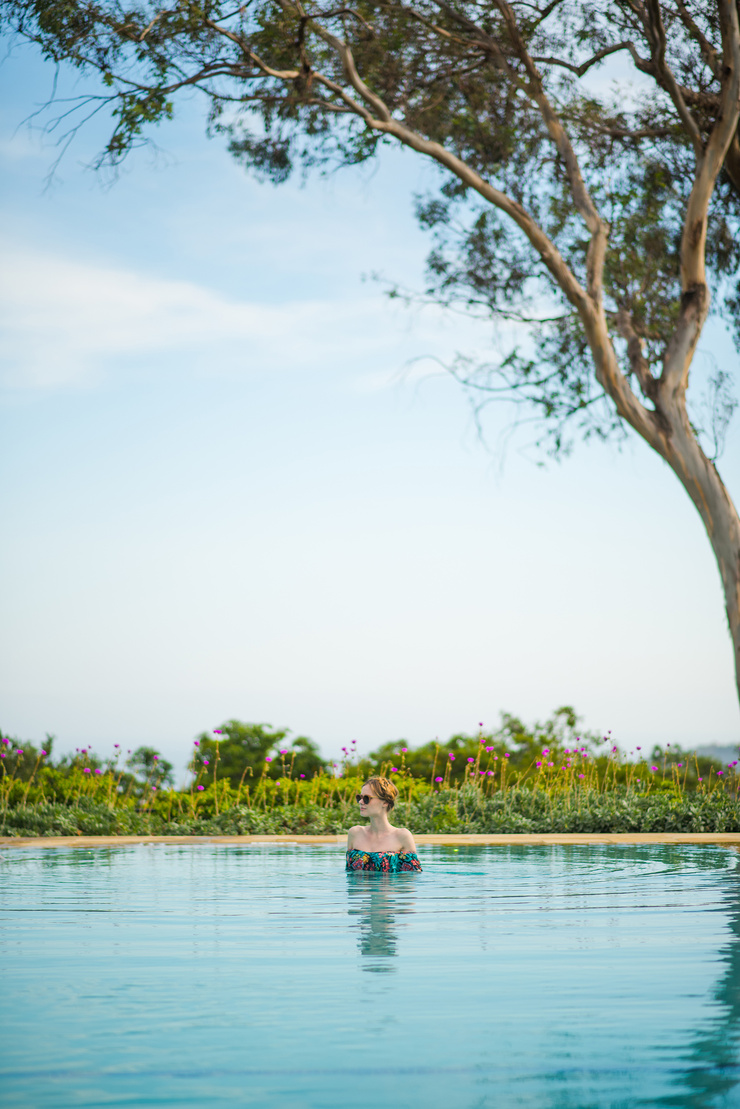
[{"left": 0, "top": 0, "right": 740, "bottom": 694}]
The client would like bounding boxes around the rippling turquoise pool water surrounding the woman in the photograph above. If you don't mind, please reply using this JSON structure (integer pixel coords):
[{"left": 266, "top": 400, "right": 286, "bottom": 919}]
[{"left": 0, "top": 845, "right": 740, "bottom": 1109}]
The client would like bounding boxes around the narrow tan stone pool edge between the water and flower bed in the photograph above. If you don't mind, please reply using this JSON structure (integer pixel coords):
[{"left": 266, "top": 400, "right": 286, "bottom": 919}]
[{"left": 0, "top": 832, "right": 740, "bottom": 848}]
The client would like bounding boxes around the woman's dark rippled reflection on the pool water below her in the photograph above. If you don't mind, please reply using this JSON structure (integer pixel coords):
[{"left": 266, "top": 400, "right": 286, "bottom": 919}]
[{"left": 347, "top": 871, "right": 414, "bottom": 974}]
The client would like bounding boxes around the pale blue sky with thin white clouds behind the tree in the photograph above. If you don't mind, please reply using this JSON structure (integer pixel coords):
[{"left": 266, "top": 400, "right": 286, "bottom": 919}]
[{"left": 0, "top": 41, "right": 740, "bottom": 765}]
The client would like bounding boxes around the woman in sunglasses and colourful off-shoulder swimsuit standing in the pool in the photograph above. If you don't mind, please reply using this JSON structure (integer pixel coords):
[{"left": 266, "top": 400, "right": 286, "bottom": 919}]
[{"left": 347, "top": 777, "right": 422, "bottom": 873}]
